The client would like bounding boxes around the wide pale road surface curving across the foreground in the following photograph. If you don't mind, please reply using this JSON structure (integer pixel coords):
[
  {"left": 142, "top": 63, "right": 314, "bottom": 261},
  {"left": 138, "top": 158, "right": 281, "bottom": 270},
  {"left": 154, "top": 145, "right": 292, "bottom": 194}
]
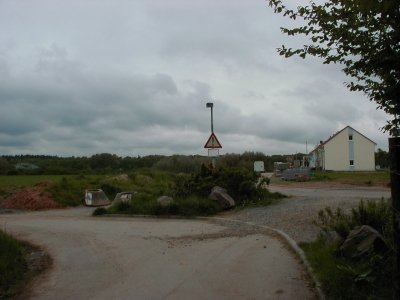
[{"left": 0, "top": 207, "right": 315, "bottom": 300}]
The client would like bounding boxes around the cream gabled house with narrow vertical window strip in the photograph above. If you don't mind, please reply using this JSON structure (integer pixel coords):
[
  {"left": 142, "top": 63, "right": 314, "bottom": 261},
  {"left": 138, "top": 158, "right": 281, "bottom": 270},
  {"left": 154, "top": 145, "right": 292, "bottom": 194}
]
[{"left": 309, "top": 126, "right": 376, "bottom": 171}]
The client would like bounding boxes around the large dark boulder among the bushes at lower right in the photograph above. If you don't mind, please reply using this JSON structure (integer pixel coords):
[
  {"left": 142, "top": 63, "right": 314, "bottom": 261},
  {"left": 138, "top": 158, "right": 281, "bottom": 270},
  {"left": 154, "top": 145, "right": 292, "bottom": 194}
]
[{"left": 339, "top": 225, "right": 388, "bottom": 258}]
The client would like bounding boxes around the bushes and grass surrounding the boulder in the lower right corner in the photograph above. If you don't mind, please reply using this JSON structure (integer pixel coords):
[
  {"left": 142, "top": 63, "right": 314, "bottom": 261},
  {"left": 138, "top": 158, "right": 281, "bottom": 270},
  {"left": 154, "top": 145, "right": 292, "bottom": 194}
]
[{"left": 301, "top": 199, "right": 395, "bottom": 299}]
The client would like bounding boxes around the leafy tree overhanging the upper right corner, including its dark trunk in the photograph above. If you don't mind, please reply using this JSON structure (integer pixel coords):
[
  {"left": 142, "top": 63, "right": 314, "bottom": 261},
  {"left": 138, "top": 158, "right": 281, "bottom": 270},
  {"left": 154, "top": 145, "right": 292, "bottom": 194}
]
[{"left": 268, "top": 0, "right": 400, "bottom": 299}]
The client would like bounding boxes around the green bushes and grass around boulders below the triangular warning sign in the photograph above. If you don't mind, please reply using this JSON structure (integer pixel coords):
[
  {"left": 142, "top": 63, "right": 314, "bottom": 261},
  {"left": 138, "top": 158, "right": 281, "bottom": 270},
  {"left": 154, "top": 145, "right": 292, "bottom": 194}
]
[{"left": 100, "top": 165, "right": 283, "bottom": 216}]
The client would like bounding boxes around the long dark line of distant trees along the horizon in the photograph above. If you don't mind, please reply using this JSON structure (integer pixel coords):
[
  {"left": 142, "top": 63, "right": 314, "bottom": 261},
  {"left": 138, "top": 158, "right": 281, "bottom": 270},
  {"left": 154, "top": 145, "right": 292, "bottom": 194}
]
[{"left": 0, "top": 152, "right": 301, "bottom": 175}]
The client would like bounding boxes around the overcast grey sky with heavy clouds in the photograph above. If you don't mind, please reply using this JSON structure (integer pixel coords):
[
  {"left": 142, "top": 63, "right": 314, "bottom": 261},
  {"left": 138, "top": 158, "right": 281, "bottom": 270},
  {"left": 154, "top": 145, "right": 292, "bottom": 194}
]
[{"left": 0, "top": 0, "right": 387, "bottom": 156}]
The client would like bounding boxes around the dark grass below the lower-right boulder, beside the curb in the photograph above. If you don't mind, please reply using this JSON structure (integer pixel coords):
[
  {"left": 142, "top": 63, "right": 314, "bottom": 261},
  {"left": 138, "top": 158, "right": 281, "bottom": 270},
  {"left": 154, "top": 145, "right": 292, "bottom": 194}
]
[{"left": 300, "top": 238, "right": 394, "bottom": 300}]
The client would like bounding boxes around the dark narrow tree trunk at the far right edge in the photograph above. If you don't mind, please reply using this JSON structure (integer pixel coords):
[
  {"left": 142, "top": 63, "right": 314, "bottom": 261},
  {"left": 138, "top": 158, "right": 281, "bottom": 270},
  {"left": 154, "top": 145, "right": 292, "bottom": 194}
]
[{"left": 389, "top": 137, "right": 400, "bottom": 299}]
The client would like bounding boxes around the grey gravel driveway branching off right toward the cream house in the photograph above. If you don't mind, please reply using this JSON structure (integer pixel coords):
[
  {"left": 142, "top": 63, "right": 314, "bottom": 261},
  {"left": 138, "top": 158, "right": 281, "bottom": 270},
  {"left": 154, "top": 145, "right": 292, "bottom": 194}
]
[{"left": 224, "top": 182, "right": 390, "bottom": 242}]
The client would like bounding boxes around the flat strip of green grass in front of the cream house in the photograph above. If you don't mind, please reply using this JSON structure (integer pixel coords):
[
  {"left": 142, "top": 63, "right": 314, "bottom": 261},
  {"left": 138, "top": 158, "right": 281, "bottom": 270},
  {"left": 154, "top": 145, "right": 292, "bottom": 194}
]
[{"left": 312, "top": 171, "right": 390, "bottom": 186}]
